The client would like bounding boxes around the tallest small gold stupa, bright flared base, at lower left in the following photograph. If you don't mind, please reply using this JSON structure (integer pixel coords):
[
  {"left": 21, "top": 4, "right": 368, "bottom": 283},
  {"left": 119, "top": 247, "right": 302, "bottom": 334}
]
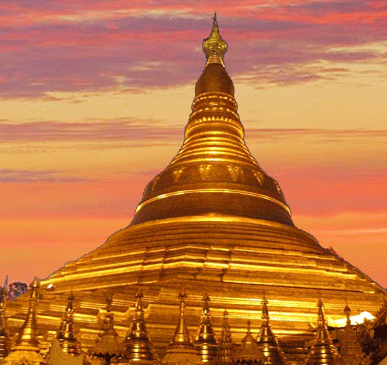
[{"left": 3, "top": 277, "right": 46, "bottom": 365}]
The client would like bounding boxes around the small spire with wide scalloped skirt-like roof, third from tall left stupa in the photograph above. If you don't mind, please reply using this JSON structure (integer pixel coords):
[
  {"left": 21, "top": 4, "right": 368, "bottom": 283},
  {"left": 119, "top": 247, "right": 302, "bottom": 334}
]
[{"left": 89, "top": 296, "right": 125, "bottom": 364}]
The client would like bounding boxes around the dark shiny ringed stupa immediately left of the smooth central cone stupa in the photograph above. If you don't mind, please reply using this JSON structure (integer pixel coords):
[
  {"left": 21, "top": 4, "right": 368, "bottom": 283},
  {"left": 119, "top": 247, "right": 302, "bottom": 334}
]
[{"left": 123, "top": 290, "right": 159, "bottom": 364}]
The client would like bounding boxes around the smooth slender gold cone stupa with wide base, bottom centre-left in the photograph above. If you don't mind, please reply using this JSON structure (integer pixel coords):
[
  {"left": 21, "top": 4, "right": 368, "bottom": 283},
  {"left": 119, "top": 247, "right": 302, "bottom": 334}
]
[{"left": 162, "top": 289, "right": 203, "bottom": 365}]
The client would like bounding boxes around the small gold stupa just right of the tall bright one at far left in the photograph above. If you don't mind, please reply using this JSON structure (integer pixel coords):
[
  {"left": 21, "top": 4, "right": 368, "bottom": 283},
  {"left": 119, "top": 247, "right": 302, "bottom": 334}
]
[{"left": 56, "top": 291, "right": 82, "bottom": 356}]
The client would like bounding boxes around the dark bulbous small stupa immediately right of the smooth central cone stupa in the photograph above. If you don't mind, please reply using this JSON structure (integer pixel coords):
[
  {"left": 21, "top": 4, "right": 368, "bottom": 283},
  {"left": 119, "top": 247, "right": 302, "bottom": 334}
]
[{"left": 195, "top": 294, "right": 218, "bottom": 364}]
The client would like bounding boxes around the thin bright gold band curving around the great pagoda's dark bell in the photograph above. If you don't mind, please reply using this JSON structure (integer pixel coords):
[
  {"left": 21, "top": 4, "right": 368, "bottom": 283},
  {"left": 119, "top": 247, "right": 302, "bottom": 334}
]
[{"left": 136, "top": 188, "right": 291, "bottom": 214}]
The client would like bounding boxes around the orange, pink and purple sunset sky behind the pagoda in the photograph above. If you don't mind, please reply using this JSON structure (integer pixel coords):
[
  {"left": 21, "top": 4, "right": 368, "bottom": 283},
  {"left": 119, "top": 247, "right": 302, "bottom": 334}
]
[{"left": 0, "top": 0, "right": 387, "bottom": 287}]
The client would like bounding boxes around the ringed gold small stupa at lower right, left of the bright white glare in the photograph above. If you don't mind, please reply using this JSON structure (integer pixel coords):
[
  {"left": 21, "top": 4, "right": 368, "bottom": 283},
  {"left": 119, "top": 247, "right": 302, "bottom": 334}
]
[{"left": 304, "top": 298, "right": 338, "bottom": 365}]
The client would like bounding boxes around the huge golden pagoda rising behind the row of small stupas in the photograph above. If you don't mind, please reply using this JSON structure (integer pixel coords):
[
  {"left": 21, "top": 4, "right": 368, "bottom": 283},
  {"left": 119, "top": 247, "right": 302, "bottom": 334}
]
[{"left": 3, "top": 12, "right": 386, "bottom": 361}]
